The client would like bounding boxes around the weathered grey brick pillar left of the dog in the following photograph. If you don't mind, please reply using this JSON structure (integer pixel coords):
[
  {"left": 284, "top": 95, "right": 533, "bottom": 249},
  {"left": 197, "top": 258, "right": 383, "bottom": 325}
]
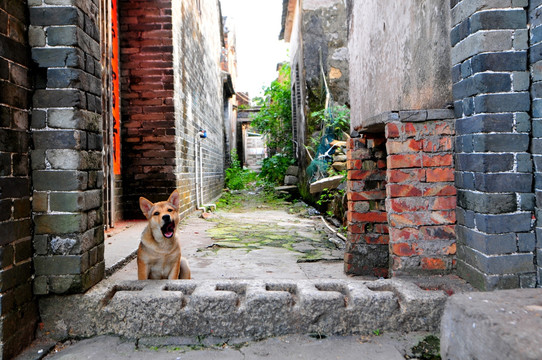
[{"left": 29, "top": 0, "right": 104, "bottom": 295}]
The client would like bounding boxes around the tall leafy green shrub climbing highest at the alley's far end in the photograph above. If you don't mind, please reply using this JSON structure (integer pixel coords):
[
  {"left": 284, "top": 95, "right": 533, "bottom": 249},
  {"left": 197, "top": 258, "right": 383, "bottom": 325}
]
[{"left": 251, "top": 64, "right": 293, "bottom": 156}]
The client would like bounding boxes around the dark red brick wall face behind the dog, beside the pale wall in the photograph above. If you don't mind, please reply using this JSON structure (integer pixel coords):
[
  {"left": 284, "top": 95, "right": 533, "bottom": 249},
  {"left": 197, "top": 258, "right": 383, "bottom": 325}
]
[{"left": 119, "top": 0, "right": 176, "bottom": 218}]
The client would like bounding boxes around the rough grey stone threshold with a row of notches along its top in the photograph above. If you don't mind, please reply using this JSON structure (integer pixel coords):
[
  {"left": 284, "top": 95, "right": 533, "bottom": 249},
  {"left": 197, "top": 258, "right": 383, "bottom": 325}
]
[{"left": 40, "top": 279, "right": 447, "bottom": 340}]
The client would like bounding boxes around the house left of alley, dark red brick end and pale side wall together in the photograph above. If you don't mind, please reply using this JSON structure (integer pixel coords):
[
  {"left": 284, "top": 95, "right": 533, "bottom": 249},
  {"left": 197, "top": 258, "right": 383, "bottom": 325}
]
[{"left": 120, "top": 0, "right": 224, "bottom": 219}]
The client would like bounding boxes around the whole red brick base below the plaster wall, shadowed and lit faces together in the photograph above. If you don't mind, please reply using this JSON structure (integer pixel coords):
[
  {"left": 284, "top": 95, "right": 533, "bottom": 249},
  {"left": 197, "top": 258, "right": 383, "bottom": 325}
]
[{"left": 345, "top": 110, "right": 456, "bottom": 276}]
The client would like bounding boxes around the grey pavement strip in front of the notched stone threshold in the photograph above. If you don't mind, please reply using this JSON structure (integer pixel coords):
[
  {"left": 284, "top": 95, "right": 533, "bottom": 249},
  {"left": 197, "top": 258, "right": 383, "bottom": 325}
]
[{"left": 34, "top": 335, "right": 412, "bottom": 360}]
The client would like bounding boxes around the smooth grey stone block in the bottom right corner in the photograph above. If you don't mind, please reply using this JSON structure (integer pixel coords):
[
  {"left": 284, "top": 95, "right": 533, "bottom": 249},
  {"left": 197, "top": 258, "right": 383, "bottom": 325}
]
[{"left": 440, "top": 289, "right": 542, "bottom": 360}]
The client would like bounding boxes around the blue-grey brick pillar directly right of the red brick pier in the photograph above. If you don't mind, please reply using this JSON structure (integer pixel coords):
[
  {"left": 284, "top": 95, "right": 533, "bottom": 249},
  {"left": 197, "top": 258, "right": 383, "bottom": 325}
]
[{"left": 451, "top": 0, "right": 536, "bottom": 290}]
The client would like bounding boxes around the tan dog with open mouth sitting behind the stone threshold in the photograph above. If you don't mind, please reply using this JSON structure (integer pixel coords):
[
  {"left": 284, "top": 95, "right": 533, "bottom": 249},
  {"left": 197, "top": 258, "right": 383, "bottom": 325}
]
[{"left": 137, "top": 190, "right": 190, "bottom": 280}]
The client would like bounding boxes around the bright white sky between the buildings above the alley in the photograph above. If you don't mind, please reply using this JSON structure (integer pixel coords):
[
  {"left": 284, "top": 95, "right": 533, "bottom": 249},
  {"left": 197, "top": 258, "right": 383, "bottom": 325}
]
[{"left": 220, "top": 0, "right": 288, "bottom": 98}]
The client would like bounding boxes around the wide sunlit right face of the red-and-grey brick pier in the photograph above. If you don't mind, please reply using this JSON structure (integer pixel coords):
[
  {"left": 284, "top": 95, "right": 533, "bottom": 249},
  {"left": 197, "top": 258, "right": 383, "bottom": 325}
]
[{"left": 386, "top": 110, "right": 456, "bottom": 276}]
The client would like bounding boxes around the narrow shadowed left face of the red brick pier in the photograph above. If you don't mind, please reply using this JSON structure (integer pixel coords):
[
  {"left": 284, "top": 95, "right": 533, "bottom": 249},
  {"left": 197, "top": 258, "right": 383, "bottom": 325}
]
[{"left": 344, "top": 134, "right": 389, "bottom": 277}]
